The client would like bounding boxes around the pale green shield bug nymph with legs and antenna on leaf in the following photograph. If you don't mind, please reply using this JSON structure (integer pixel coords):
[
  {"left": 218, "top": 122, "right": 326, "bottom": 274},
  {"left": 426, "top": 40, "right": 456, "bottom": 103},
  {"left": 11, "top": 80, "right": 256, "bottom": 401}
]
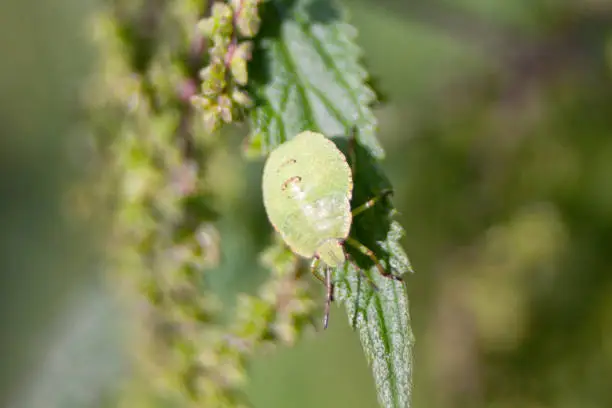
[{"left": 263, "top": 131, "right": 401, "bottom": 327}]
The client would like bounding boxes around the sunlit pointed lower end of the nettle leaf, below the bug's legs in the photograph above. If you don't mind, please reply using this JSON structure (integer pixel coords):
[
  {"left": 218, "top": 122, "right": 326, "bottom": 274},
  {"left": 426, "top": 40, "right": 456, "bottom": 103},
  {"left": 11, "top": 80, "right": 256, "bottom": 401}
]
[{"left": 336, "top": 222, "right": 414, "bottom": 408}]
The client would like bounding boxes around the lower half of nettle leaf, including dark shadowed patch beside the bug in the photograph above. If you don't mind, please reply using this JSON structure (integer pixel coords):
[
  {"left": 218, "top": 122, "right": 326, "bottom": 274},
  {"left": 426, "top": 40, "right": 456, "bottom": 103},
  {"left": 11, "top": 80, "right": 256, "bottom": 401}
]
[{"left": 334, "top": 138, "right": 414, "bottom": 408}]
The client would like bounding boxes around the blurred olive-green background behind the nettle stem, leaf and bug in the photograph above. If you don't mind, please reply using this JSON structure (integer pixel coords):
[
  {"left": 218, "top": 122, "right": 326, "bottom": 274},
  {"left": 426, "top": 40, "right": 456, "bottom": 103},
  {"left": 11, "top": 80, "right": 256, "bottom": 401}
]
[{"left": 0, "top": 0, "right": 612, "bottom": 408}]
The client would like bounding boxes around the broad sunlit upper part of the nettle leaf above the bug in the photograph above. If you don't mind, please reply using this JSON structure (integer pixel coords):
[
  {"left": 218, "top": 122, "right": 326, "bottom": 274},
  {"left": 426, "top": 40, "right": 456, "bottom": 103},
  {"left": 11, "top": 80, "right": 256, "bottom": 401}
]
[{"left": 249, "top": 0, "right": 384, "bottom": 158}]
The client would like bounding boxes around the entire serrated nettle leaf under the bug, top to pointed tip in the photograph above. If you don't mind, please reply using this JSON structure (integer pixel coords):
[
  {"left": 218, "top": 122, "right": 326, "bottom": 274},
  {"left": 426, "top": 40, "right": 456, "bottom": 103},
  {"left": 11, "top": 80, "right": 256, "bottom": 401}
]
[{"left": 247, "top": 0, "right": 414, "bottom": 408}]
